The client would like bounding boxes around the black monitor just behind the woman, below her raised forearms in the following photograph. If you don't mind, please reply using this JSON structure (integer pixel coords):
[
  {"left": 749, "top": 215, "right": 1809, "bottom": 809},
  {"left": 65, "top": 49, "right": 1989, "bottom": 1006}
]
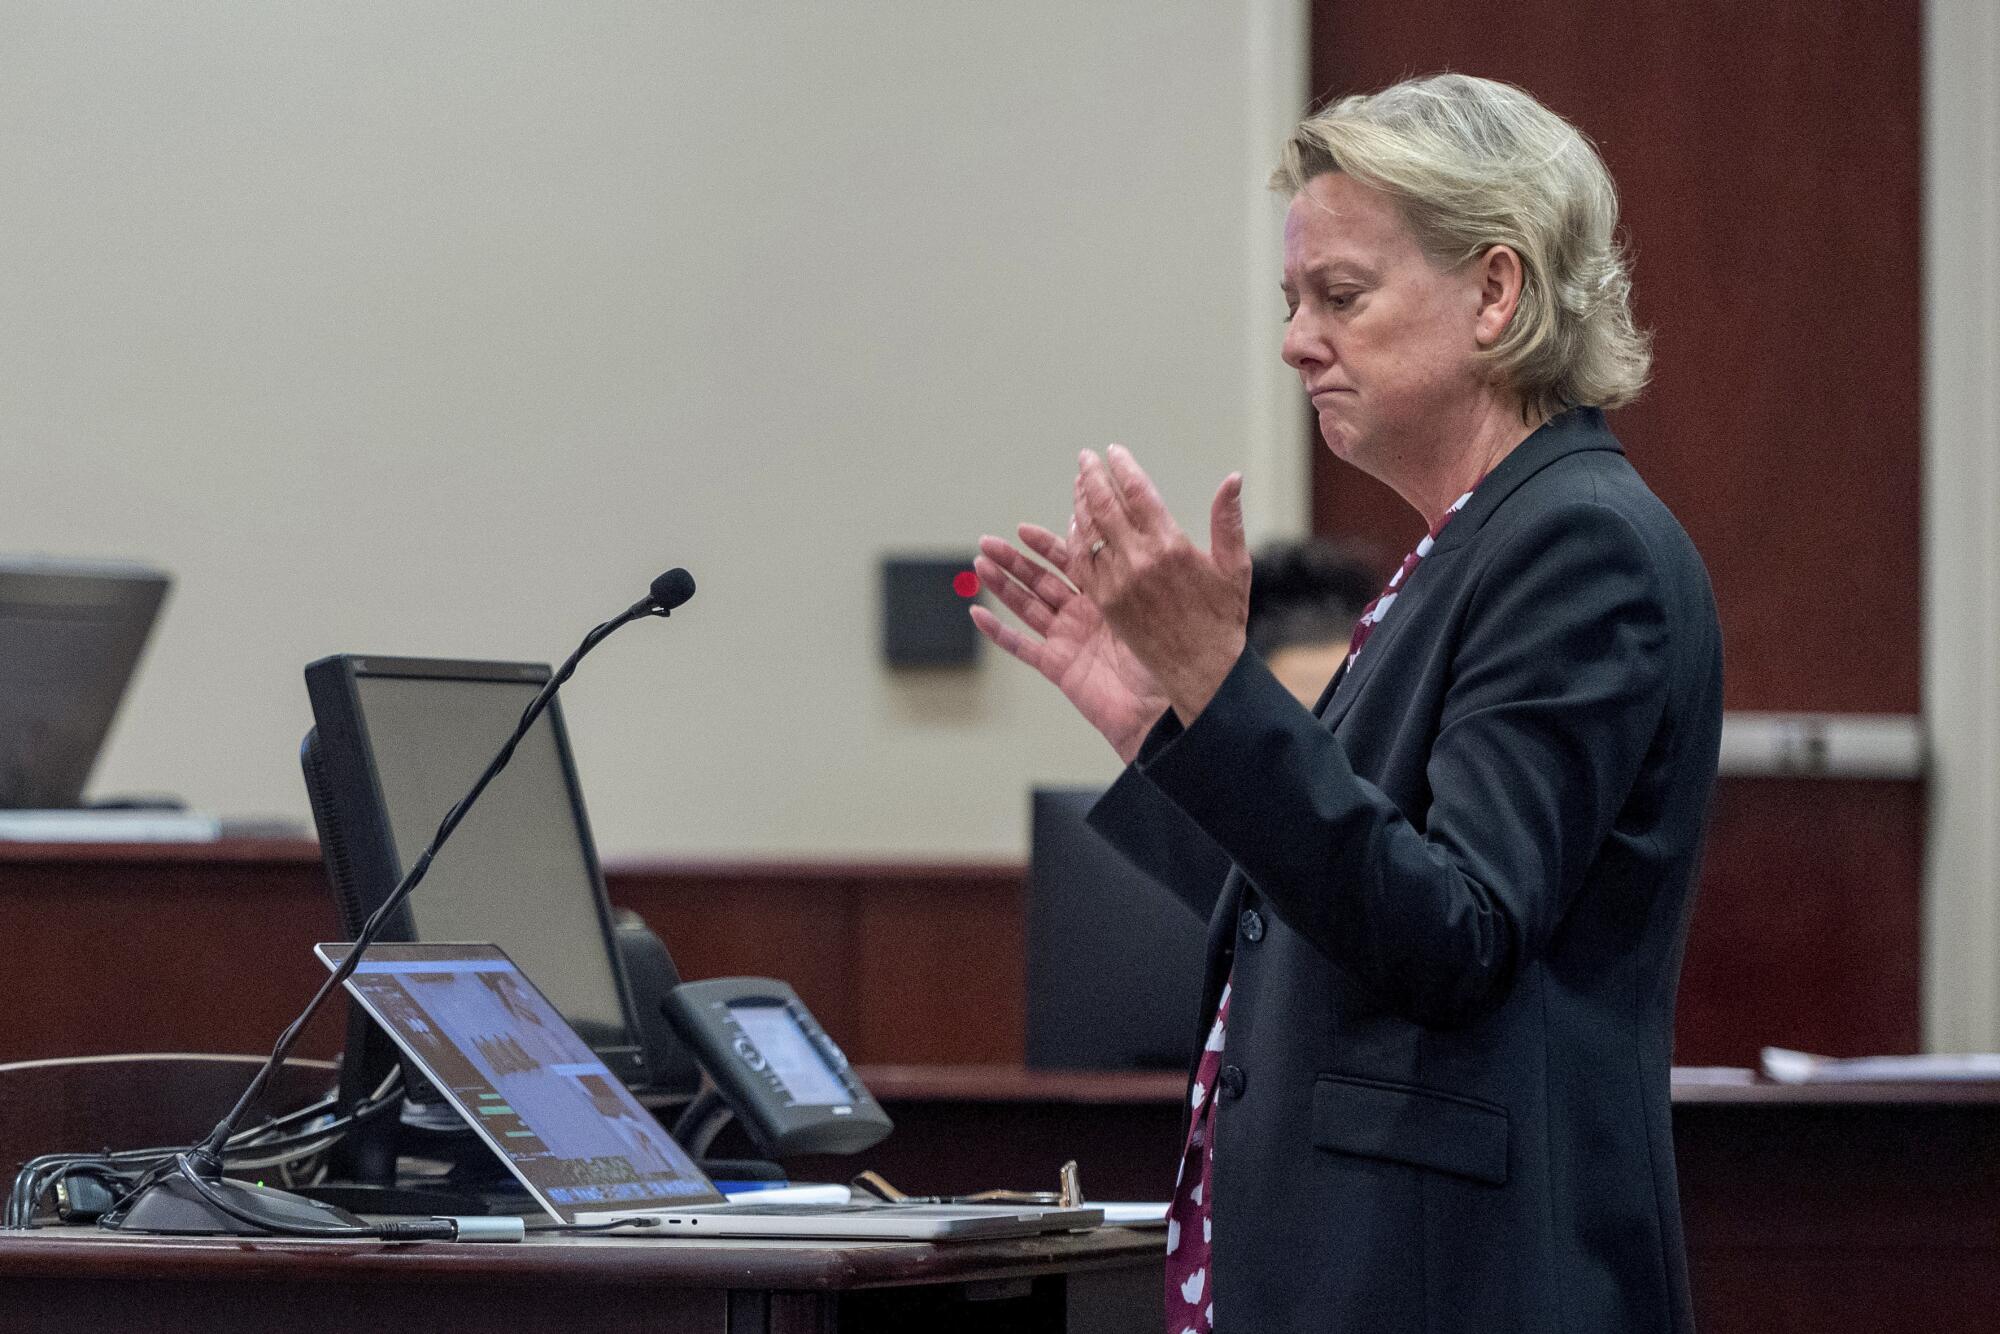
[{"left": 1028, "top": 788, "right": 1208, "bottom": 1070}]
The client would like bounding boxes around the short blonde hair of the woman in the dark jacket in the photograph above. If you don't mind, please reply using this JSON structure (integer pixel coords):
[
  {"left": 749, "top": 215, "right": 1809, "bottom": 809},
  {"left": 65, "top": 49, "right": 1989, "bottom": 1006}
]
[{"left": 1270, "top": 74, "right": 1652, "bottom": 416}]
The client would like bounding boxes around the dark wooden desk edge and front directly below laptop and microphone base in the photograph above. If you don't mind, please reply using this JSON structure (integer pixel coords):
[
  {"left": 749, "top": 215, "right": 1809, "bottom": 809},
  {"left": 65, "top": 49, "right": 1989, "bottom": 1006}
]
[{"left": 0, "top": 1228, "right": 1164, "bottom": 1334}]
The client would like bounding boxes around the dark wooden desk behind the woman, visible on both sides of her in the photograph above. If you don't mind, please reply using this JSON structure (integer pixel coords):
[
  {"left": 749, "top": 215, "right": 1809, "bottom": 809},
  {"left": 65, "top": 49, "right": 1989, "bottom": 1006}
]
[{"left": 824, "top": 1066, "right": 2000, "bottom": 1334}]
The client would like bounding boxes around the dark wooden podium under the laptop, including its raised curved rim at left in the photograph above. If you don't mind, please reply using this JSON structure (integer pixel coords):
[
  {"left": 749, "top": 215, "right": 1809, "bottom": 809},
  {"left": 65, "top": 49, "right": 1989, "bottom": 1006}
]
[{"left": 0, "top": 1054, "right": 1178, "bottom": 1334}]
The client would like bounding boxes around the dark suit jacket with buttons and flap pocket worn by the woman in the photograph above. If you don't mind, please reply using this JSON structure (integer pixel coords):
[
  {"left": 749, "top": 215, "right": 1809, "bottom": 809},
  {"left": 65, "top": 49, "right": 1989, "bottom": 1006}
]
[{"left": 1090, "top": 410, "right": 1722, "bottom": 1334}]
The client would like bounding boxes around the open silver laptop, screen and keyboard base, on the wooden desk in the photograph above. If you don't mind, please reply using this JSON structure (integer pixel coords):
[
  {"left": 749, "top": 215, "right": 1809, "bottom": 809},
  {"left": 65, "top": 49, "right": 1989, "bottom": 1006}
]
[{"left": 314, "top": 942, "right": 1104, "bottom": 1242}]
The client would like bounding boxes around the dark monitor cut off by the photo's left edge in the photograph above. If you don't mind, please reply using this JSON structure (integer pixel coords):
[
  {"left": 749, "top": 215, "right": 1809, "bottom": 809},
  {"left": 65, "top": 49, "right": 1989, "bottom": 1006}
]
[{"left": 0, "top": 556, "right": 172, "bottom": 810}]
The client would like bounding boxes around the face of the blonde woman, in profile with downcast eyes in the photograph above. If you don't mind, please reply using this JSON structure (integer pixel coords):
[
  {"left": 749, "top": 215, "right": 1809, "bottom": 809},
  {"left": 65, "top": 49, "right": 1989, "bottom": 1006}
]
[{"left": 1284, "top": 172, "right": 1486, "bottom": 476}]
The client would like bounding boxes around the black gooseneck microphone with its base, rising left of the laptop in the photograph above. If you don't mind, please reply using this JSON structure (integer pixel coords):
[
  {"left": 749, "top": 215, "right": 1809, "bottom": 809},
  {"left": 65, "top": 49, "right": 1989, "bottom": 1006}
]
[{"left": 102, "top": 566, "right": 694, "bottom": 1240}]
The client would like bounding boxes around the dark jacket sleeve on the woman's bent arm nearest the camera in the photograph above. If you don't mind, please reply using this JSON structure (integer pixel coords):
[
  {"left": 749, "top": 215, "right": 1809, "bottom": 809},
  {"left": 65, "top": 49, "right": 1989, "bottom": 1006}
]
[{"left": 1140, "top": 502, "right": 1668, "bottom": 1024}]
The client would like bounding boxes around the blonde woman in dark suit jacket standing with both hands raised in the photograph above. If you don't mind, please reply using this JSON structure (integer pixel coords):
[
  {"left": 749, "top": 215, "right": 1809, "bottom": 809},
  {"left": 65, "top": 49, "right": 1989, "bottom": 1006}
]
[{"left": 974, "top": 76, "right": 1722, "bottom": 1334}]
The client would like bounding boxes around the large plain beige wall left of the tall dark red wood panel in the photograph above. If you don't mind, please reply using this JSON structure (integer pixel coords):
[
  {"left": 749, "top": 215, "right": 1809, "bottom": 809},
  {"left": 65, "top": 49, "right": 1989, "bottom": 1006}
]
[{"left": 0, "top": 0, "right": 1304, "bottom": 856}]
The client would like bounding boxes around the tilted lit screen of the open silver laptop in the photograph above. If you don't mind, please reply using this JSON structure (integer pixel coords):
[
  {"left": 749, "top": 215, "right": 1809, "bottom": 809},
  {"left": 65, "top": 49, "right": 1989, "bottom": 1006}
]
[{"left": 316, "top": 944, "right": 722, "bottom": 1220}]
